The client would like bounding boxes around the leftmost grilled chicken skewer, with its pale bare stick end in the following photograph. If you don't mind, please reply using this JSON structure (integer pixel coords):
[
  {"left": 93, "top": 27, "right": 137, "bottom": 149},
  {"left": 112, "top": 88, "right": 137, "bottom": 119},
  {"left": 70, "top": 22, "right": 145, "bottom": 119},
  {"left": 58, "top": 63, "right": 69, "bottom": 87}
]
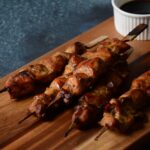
[{"left": 0, "top": 36, "right": 107, "bottom": 99}]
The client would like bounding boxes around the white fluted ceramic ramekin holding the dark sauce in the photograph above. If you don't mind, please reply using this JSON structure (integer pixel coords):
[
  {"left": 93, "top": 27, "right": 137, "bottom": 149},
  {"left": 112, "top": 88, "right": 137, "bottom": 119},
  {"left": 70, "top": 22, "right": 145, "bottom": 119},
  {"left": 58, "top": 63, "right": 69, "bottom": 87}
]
[{"left": 111, "top": 0, "right": 150, "bottom": 40}]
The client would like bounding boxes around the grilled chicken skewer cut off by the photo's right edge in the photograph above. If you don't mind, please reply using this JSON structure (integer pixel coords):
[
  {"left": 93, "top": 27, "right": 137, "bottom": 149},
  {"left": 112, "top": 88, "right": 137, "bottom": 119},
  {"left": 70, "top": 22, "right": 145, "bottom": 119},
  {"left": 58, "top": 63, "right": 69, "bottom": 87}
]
[{"left": 100, "top": 70, "right": 150, "bottom": 132}]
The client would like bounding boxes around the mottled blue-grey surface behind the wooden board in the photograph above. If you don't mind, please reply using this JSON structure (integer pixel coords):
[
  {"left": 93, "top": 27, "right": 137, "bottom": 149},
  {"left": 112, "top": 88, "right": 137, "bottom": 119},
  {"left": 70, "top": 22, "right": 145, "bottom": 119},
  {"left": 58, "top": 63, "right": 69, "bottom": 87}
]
[{"left": 0, "top": 0, "right": 113, "bottom": 77}]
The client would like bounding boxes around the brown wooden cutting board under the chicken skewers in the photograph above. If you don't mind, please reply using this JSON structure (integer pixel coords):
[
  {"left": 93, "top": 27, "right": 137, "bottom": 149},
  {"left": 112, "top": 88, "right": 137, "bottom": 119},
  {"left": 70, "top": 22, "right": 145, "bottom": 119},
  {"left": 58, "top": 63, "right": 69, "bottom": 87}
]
[{"left": 0, "top": 18, "right": 150, "bottom": 150}]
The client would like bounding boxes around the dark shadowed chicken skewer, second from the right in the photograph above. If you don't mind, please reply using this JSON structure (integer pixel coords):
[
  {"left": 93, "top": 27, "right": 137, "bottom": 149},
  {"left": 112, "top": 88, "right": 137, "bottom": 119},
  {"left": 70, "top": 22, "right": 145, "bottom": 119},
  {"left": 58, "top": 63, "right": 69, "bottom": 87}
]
[{"left": 65, "top": 61, "right": 129, "bottom": 136}]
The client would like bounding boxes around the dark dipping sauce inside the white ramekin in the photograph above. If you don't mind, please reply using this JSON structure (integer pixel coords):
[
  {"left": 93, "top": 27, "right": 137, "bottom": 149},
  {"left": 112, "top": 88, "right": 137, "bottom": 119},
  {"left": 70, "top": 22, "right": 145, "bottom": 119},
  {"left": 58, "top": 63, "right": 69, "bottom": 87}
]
[{"left": 120, "top": 0, "right": 150, "bottom": 14}]
